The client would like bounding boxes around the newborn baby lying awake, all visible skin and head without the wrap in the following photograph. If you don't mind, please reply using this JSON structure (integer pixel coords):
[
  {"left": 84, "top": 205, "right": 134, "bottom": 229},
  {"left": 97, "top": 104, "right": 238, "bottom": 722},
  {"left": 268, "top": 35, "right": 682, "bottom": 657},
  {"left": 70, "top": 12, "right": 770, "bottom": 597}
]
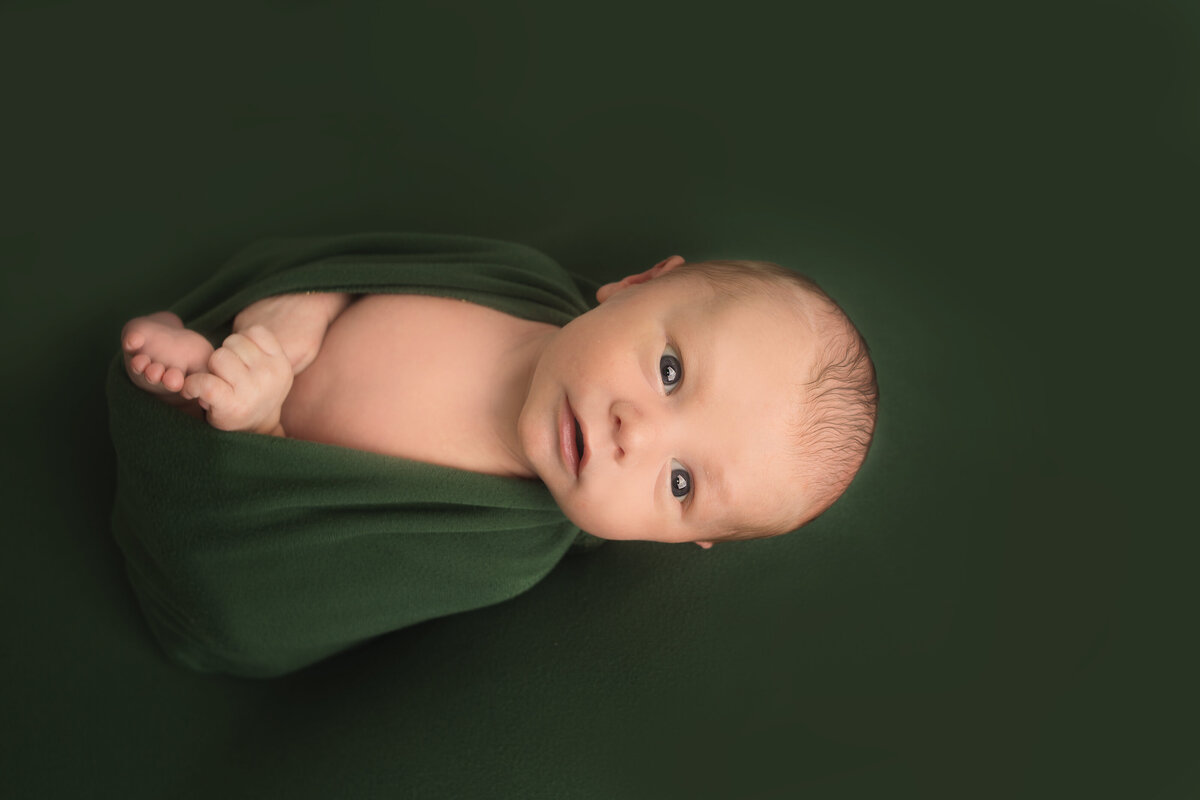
[{"left": 121, "top": 255, "right": 877, "bottom": 548}]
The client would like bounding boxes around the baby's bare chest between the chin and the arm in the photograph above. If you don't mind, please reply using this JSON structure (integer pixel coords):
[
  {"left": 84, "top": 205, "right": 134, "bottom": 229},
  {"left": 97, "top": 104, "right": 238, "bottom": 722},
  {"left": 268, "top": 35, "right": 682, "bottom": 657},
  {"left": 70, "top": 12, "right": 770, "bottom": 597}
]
[{"left": 282, "top": 295, "right": 550, "bottom": 473}]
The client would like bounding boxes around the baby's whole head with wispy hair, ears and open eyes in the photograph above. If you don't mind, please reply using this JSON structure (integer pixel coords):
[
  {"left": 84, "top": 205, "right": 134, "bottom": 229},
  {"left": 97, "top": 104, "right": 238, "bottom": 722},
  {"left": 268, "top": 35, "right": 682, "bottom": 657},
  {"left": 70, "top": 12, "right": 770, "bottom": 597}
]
[{"left": 518, "top": 257, "right": 878, "bottom": 547}]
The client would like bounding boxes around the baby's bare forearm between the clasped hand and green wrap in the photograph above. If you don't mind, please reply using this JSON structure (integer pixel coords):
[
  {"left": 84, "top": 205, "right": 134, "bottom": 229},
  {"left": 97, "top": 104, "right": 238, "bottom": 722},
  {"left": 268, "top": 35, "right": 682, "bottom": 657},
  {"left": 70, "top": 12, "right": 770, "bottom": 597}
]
[{"left": 233, "top": 291, "right": 354, "bottom": 374}]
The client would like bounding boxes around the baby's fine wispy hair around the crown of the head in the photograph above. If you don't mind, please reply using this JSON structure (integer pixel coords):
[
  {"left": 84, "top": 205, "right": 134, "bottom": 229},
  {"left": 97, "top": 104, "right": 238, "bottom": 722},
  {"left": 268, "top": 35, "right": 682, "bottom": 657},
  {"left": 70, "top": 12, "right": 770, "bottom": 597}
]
[{"left": 664, "top": 260, "right": 880, "bottom": 541}]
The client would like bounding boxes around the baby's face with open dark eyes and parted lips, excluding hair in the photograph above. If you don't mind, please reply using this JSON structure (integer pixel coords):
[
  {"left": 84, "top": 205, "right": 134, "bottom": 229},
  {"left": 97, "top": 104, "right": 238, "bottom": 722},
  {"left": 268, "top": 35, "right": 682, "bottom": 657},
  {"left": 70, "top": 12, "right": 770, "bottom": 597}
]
[{"left": 518, "top": 266, "right": 816, "bottom": 542}]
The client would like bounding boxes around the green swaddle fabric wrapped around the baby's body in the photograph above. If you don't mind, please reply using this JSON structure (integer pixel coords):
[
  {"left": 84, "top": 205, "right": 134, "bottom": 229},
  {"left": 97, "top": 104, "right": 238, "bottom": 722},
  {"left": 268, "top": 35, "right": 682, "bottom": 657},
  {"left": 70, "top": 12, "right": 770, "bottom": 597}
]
[{"left": 107, "top": 234, "right": 601, "bottom": 676}]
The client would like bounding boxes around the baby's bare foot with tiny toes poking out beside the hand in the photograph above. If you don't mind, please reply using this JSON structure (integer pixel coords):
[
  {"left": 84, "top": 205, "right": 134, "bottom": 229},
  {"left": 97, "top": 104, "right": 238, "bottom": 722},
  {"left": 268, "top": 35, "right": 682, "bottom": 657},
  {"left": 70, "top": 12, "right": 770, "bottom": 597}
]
[{"left": 121, "top": 311, "right": 212, "bottom": 395}]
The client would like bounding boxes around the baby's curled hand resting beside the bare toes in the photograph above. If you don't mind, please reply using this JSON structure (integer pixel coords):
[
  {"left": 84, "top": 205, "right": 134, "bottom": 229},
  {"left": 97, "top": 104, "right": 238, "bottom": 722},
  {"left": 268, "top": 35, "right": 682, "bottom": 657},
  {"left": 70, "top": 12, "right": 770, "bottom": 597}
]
[{"left": 180, "top": 325, "right": 293, "bottom": 433}]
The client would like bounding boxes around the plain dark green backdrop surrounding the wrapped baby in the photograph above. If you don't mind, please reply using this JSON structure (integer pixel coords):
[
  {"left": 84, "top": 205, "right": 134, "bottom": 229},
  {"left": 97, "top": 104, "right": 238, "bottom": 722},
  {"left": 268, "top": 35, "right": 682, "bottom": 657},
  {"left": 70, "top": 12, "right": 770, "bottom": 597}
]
[{"left": 0, "top": 0, "right": 1200, "bottom": 799}]
